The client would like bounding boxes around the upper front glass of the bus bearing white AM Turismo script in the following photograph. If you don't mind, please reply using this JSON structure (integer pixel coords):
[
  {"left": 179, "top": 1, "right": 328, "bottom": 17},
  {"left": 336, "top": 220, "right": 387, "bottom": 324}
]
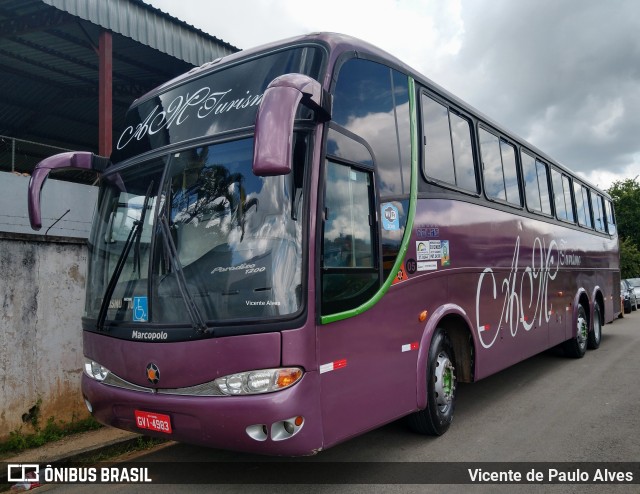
[{"left": 112, "top": 46, "right": 324, "bottom": 163}]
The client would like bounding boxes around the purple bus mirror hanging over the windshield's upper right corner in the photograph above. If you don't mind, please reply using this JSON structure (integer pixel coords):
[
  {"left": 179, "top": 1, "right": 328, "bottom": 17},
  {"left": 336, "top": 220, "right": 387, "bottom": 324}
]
[{"left": 253, "top": 74, "right": 331, "bottom": 177}]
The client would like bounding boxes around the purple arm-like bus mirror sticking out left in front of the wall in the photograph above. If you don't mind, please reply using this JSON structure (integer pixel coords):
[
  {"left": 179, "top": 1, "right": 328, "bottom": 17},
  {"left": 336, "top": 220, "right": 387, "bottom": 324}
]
[{"left": 28, "top": 151, "right": 109, "bottom": 230}]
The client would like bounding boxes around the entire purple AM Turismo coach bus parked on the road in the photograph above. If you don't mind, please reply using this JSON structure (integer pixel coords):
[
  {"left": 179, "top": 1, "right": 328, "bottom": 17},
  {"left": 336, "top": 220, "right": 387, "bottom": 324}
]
[{"left": 29, "top": 34, "right": 620, "bottom": 455}]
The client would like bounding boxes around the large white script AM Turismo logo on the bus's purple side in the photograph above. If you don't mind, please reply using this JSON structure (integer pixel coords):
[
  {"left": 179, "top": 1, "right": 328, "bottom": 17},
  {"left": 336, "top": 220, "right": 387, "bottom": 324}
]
[{"left": 476, "top": 236, "right": 582, "bottom": 348}]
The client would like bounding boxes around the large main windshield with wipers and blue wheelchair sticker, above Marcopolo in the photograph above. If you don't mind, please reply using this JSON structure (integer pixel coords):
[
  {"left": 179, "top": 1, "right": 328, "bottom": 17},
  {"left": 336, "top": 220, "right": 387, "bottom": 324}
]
[{"left": 86, "top": 135, "right": 306, "bottom": 325}]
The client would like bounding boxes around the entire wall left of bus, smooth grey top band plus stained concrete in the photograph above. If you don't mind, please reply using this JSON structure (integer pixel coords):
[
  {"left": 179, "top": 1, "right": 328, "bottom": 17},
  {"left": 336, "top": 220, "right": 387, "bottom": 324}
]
[{"left": 0, "top": 173, "right": 97, "bottom": 441}]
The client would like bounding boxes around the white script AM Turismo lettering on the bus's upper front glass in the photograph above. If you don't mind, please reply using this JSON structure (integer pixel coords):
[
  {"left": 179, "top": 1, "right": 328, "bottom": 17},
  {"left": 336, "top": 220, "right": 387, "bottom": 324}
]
[{"left": 116, "top": 86, "right": 264, "bottom": 150}]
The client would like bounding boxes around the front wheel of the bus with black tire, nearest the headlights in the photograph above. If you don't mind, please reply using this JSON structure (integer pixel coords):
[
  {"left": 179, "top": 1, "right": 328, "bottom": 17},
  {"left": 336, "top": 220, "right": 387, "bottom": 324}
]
[{"left": 408, "top": 328, "right": 456, "bottom": 436}]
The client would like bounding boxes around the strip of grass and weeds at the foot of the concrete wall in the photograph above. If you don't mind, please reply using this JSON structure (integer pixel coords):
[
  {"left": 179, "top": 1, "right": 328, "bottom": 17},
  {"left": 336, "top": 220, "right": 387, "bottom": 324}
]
[{"left": 0, "top": 417, "right": 102, "bottom": 456}]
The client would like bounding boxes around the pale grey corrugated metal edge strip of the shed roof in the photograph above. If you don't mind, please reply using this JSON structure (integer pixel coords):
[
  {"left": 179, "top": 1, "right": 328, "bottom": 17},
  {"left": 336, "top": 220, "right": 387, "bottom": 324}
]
[{"left": 42, "top": 0, "right": 238, "bottom": 66}]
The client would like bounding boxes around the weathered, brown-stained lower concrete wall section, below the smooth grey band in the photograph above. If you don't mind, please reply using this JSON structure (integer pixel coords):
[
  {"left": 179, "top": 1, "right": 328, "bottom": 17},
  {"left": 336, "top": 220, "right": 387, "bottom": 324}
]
[{"left": 0, "top": 235, "right": 87, "bottom": 440}]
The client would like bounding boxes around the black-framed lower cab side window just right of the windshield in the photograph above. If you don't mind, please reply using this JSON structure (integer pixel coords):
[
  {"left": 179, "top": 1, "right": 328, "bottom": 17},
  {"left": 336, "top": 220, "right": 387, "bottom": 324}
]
[{"left": 322, "top": 161, "right": 379, "bottom": 315}]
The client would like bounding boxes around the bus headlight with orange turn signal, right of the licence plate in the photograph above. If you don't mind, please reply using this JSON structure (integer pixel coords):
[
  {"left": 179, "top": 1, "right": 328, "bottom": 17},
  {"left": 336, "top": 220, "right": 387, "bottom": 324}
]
[{"left": 215, "top": 367, "right": 303, "bottom": 395}]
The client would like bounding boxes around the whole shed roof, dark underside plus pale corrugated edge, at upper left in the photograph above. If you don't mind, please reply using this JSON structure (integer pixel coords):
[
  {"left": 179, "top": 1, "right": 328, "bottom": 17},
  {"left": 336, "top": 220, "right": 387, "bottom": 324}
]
[{"left": 0, "top": 0, "right": 237, "bottom": 182}]
